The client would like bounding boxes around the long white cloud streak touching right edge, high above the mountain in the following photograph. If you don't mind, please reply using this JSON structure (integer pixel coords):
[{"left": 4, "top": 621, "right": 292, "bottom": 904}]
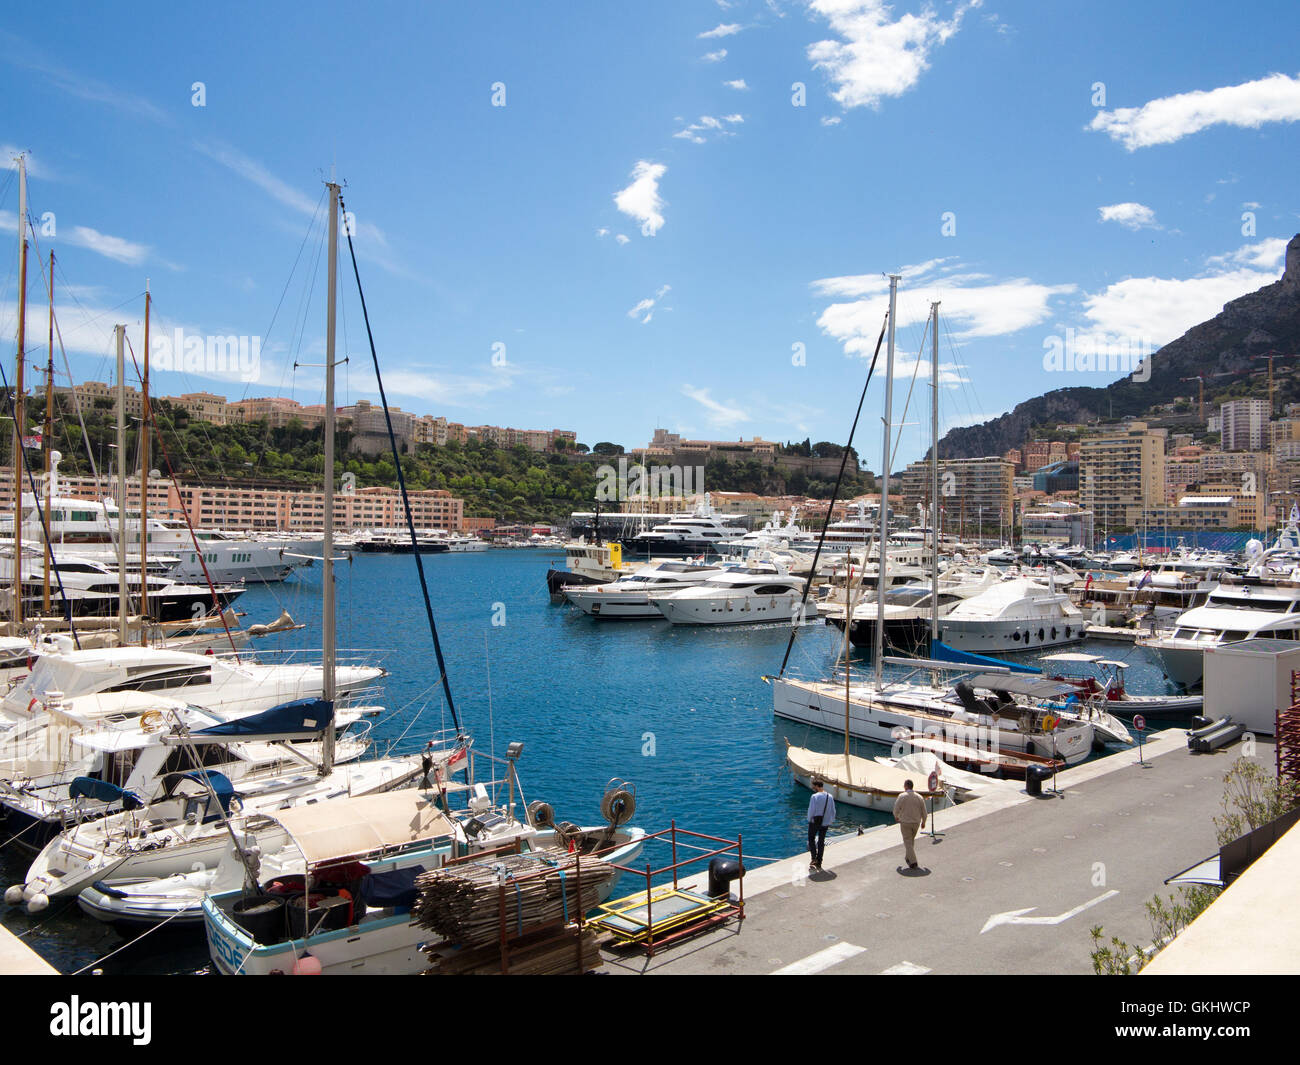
[{"left": 1088, "top": 74, "right": 1300, "bottom": 152}]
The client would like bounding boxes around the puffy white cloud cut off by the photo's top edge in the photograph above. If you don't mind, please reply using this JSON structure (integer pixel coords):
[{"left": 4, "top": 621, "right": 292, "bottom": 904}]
[{"left": 807, "top": 0, "right": 982, "bottom": 109}]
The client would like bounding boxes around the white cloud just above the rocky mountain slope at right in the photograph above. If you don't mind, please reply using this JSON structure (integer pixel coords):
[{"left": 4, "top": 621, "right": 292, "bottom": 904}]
[{"left": 1083, "top": 239, "right": 1286, "bottom": 347}]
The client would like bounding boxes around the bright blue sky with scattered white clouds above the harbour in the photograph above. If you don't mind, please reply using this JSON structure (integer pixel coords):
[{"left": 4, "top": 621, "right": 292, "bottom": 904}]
[{"left": 0, "top": 0, "right": 1300, "bottom": 469}]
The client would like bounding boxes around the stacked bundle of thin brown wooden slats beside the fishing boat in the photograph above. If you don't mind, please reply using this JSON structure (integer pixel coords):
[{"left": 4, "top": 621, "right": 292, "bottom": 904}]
[{"left": 412, "top": 849, "right": 618, "bottom": 947}]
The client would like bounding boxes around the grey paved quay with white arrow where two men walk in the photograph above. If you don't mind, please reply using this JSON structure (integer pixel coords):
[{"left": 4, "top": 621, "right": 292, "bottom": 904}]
[{"left": 603, "top": 728, "right": 1253, "bottom": 974}]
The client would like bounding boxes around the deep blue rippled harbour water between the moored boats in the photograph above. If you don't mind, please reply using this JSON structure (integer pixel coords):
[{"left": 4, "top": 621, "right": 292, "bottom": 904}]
[{"left": 0, "top": 550, "right": 1180, "bottom": 973}]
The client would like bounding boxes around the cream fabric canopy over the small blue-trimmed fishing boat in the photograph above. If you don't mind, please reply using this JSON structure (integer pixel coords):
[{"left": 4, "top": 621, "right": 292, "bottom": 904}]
[{"left": 266, "top": 788, "right": 456, "bottom": 865}]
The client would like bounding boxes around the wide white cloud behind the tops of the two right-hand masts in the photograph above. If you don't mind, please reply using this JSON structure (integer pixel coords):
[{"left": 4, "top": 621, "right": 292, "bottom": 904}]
[{"left": 813, "top": 259, "right": 1076, "bottom": 356}]
